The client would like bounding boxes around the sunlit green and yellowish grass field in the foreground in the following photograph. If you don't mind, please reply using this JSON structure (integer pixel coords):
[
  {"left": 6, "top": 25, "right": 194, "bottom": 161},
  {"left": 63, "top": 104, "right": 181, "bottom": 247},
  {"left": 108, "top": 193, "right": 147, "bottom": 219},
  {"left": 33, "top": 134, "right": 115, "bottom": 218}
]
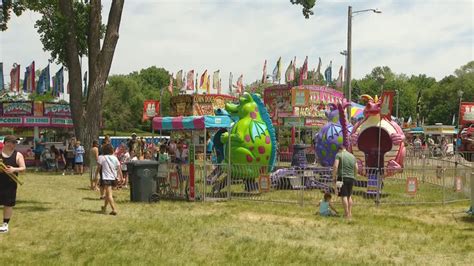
[{"left": 0, "top": 173, "right": 474, "bottom": 265}]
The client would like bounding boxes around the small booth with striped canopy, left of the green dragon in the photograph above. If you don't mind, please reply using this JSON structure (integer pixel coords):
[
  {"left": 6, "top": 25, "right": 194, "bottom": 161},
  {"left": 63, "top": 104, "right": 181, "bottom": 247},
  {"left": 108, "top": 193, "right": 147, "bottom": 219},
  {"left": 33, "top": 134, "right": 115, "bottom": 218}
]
[{"left": 153, "top": 115, "right": 232, "bottom": 201}]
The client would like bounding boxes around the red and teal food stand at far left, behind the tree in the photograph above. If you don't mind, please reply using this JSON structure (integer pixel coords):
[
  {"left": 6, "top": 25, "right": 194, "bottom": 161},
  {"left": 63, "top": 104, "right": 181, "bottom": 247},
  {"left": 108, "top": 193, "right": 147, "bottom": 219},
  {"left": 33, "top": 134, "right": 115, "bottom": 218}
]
[{"left": 0, "top": 101, "right": 73, "bottom": 165}]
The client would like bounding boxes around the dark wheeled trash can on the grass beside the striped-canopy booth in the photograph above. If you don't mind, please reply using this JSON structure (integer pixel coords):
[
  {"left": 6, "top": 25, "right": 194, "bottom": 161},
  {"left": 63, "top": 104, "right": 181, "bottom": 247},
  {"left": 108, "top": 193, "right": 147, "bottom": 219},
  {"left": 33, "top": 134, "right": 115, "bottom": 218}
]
[{"left": 127, "top": 160, "right": 159, "bottom": 202}]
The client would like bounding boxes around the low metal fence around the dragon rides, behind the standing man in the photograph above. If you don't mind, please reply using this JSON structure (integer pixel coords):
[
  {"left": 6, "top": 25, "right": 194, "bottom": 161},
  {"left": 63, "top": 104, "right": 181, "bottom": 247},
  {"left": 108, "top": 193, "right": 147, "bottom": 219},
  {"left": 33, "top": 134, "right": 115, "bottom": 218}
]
[{"left": 188, "top": 161, "right": 474, "bottom": 205}]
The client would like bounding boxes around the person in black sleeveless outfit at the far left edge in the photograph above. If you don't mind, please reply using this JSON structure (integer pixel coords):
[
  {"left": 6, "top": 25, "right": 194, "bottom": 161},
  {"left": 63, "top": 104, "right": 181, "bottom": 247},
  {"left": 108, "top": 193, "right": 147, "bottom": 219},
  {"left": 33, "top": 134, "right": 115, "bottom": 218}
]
[{"left": 0, "top": 135, "right": 26, "bottom": 233}]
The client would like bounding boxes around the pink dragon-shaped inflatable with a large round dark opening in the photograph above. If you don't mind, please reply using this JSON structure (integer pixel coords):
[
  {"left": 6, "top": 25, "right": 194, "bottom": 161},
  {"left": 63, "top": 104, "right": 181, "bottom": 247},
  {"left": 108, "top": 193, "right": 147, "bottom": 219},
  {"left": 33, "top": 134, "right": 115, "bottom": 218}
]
[{"left": 351, "top": 95, "right": 405, "bottom": 176}]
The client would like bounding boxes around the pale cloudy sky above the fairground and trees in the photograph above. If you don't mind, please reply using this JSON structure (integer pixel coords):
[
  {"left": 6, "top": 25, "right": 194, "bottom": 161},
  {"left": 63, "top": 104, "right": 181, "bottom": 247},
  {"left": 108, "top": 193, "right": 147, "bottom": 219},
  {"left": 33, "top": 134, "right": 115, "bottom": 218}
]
[{"left": 0, "top": 0, "right": 474, "bottom": 94}]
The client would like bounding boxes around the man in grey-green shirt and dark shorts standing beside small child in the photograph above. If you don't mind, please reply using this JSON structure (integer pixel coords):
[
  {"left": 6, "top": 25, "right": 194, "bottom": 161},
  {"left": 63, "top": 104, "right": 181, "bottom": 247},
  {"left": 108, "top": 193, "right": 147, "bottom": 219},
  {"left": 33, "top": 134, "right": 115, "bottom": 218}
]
[{"left": 332, "top": 145, "right": 359, "bottom": 219}]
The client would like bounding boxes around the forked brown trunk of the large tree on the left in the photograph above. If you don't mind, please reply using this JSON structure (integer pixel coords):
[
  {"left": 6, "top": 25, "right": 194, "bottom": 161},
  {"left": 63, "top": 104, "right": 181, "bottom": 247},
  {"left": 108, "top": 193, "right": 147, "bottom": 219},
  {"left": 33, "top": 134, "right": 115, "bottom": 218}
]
[{"left": 59, "top": 0, "right": 124, "bottom": 163}]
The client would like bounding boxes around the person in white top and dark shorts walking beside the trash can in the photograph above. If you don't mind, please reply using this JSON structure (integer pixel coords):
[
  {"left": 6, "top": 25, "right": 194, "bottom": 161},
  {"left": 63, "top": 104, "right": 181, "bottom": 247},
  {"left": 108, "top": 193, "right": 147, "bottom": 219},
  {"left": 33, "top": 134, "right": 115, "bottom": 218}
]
[{"left": 97, "top": 144, "right": 122, "bottom": 215}]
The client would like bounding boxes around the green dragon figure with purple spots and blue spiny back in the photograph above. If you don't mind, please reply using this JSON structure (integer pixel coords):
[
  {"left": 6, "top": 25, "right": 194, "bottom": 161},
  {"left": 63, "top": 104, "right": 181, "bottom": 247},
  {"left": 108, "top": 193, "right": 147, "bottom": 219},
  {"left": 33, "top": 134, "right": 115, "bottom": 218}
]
[{"left": 221, "top": 93, "right": 276, "bottom": 180}]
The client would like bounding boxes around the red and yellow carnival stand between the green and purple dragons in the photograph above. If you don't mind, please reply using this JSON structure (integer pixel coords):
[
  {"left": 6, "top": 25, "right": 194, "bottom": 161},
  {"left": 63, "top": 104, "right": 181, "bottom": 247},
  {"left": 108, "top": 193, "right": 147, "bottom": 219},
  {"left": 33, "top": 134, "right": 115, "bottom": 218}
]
[{"left": 263, "top": 85, "right": 364, "bottom": 162}]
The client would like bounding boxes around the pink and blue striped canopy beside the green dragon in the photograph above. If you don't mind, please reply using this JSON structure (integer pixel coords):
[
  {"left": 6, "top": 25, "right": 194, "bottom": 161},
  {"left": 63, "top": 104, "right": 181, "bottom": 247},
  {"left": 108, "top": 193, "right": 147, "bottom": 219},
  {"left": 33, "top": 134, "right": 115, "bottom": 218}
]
[{"left": 153, "top": 115, "right": 232, "bottom": 130}]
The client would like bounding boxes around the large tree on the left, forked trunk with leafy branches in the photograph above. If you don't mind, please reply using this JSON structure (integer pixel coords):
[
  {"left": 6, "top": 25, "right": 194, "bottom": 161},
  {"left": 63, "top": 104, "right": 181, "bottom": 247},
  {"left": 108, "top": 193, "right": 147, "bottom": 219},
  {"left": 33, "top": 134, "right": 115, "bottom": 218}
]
[{"left": 0, "top": 0, "right": 124, "bottom": 161}]
